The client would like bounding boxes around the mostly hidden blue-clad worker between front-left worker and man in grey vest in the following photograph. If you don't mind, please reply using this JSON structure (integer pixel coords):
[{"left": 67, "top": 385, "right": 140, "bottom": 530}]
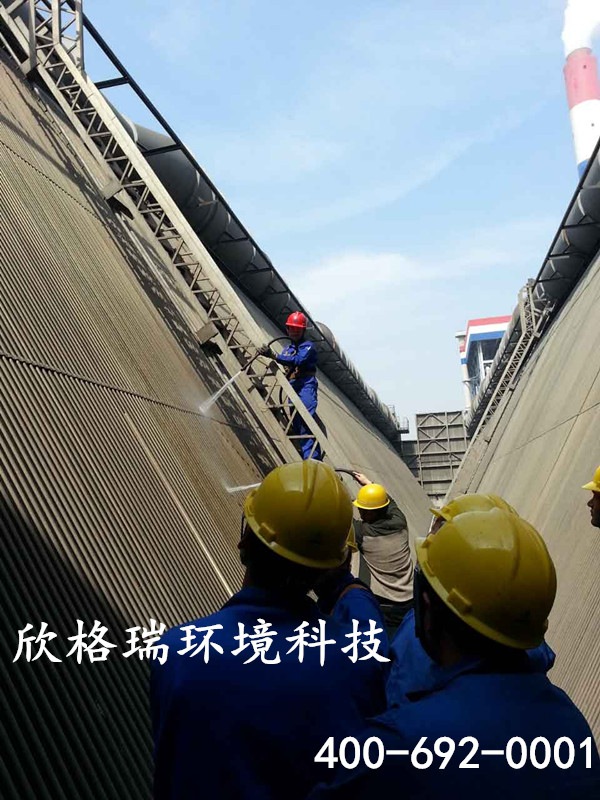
[{"left": 314, "top": 527, "right": 389, "bottom": 657}]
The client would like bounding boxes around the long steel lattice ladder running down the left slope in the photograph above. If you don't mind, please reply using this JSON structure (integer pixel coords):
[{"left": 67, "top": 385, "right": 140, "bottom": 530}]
[{"left": 0, "top": 0, "right": 332, "bottom": 460}]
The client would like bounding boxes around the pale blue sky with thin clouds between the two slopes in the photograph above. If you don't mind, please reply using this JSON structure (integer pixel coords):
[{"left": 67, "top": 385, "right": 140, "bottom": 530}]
[{"left": 85, "top": 0, "right": 577, "bottom": 432}]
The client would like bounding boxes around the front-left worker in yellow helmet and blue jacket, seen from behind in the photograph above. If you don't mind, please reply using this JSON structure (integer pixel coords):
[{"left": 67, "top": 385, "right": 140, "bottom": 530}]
[{"left": 151, "top": 460, "right": 385, "bottom": 800}]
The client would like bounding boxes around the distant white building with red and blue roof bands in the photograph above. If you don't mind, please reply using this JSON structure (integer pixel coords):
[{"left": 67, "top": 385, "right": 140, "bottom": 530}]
[{"left": 456, "top": 314, "right": 511, "bottom": 413}]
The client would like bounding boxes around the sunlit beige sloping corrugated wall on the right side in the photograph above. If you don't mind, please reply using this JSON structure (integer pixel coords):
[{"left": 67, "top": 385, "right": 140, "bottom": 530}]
[{"left": 458, "top": 247, "right": 600, "bottom": 740}]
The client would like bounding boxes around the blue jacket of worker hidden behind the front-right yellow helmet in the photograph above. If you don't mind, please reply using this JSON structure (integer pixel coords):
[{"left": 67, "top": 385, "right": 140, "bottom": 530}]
[{"left": 386, "top": 609, "right": 556, "bottom": 706}]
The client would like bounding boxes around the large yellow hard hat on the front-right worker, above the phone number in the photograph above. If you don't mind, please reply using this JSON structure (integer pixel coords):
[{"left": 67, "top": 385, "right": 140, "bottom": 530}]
[{"left": 415, "top": 508, "right": 556, "bottom": 650}]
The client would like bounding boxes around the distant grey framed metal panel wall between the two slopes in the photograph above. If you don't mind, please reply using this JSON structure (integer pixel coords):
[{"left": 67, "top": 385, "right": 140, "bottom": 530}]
[{"left": 402, "top": 411, "right": 468, "bottom": 507}]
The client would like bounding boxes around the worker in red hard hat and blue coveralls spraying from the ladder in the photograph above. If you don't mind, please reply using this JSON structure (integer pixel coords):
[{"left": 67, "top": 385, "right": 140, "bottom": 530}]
[{"left": 259, "top": 311, "right": 323, "bottom": 461}]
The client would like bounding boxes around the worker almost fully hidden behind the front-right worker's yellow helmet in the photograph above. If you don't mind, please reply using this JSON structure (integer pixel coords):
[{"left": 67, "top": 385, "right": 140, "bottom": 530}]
[{"left": 386, "top": 494, "right": 556, "bottom": 707}]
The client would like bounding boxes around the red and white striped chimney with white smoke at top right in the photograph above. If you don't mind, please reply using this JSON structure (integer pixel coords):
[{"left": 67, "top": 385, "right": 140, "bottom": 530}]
[{"left": 562, "top": 0, "right": 600, "bottom": 177}]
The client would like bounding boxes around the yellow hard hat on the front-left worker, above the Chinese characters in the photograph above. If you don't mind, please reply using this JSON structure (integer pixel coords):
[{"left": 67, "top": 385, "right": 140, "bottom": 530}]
[{"left": 244, "top": 459, "right": 352, "bottom": 569}]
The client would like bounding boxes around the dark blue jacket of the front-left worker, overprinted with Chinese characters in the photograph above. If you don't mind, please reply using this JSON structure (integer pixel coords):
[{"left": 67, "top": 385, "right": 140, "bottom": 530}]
[{"left": 151, "top": 588, "right": 385, "bottom": 800}]
